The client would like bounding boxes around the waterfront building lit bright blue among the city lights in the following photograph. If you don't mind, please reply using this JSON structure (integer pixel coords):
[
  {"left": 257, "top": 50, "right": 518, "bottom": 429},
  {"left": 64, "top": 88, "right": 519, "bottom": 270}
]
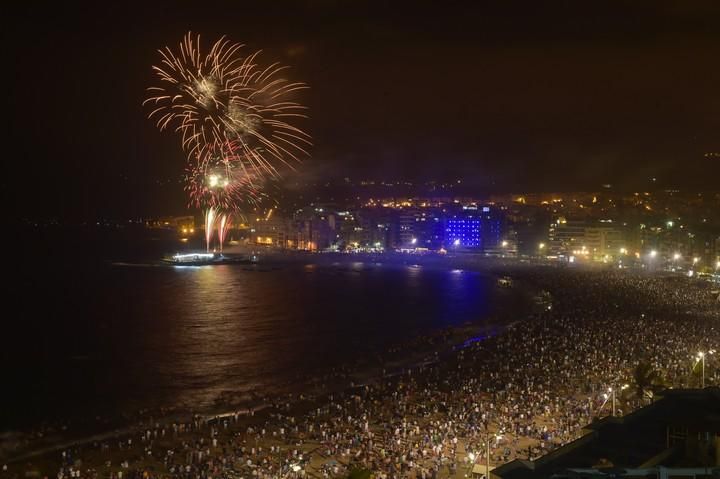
[{"left": 445, "top": 206, "right": 502, "bottom": 250}]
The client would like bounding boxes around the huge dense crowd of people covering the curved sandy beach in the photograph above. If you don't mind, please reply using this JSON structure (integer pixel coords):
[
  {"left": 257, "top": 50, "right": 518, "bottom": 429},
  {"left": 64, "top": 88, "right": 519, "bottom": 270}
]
[{"left": 0, "top": 268, "right": 720, "bottom": 479}]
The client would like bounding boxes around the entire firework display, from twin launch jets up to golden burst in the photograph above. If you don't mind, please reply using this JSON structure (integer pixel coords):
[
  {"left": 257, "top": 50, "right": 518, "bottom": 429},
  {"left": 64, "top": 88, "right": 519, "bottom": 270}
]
[{"left": 143, "top": 33, "right": 311, "bottom": 252}]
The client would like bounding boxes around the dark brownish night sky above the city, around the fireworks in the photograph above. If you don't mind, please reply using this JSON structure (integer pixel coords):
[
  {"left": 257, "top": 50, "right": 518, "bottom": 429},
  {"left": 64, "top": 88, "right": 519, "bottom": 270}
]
[{"left": 2, "top": 0, "right": 720, "bottom": 218}]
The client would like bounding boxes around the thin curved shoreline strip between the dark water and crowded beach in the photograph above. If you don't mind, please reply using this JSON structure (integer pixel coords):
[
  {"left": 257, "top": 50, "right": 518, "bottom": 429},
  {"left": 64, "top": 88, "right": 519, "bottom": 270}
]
[{"left": 0, "top": 254, "right": 535, "bottom": 464}]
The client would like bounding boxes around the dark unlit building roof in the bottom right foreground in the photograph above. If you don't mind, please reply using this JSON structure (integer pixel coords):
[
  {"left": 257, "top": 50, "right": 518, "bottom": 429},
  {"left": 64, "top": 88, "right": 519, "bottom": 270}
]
[{"left": 491, "top": 387, "right": 720, "bottom": 479}]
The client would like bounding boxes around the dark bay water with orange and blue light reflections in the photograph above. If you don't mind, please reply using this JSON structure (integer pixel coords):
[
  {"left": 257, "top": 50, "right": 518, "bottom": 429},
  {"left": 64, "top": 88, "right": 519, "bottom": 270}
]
[{"left": 0, "top": 227, "right": 523, "bottom": 431}]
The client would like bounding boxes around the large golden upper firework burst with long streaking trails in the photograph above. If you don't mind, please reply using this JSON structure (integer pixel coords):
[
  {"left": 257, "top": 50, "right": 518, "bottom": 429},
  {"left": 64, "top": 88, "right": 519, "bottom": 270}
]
[{"left": 144, "top": 33, "right": 311, "bottom": 176}]
